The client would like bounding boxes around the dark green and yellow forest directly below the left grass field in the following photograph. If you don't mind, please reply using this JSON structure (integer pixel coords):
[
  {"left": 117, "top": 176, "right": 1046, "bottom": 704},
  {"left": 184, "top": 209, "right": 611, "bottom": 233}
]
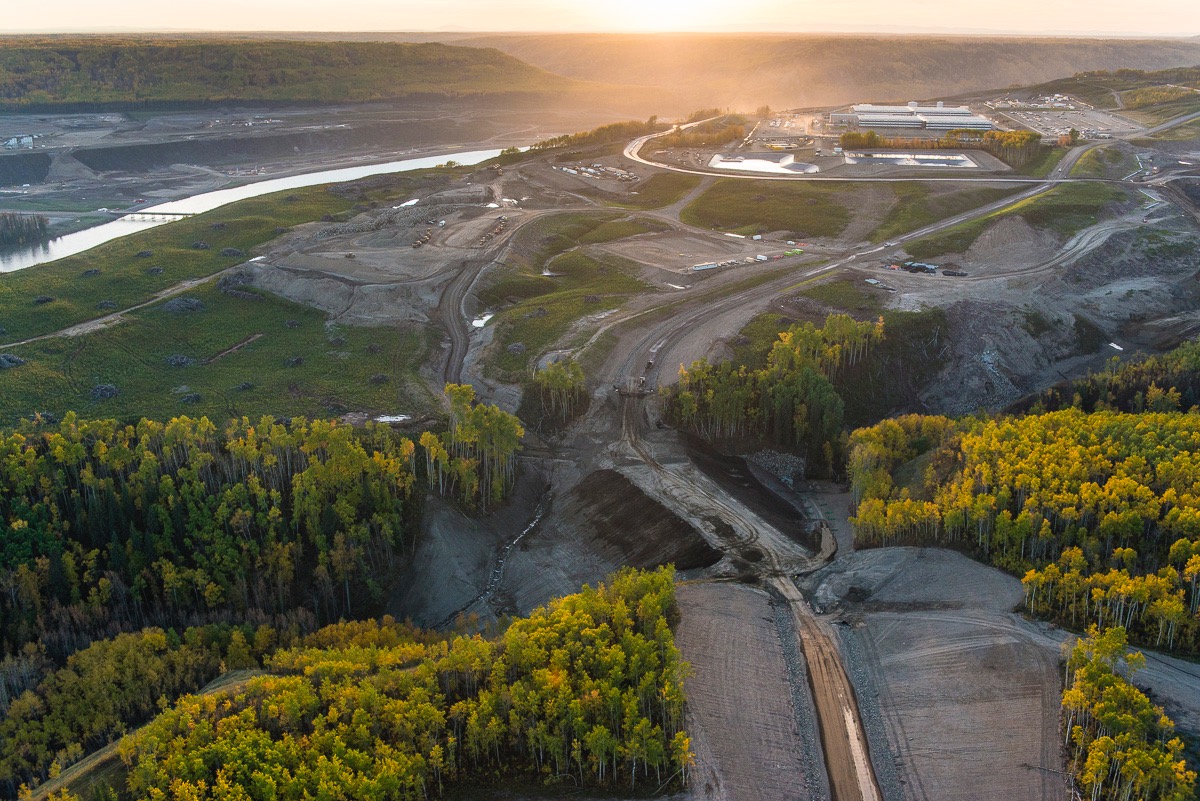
[{"left": 0, "top": 385, "right": 524, "bottom": 660}]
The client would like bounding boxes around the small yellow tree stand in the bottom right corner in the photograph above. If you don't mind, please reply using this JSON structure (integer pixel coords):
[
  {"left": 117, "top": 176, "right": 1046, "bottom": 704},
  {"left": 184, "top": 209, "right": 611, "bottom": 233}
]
[{"left": 1062, "top": 626, "right": 1196, "bottom": 801}]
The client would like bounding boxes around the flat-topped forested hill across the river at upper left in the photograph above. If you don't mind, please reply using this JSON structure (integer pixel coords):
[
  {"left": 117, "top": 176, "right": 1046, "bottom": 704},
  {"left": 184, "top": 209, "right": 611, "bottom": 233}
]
[{"left": 0, "top": 38, "right": 590, "bottom": 110}]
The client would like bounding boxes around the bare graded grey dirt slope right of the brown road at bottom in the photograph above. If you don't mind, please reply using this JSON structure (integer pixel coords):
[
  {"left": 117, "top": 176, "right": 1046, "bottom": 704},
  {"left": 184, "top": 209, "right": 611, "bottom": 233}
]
[{"left": 816, "top": 548, "right": 1067, "bottom": 801}]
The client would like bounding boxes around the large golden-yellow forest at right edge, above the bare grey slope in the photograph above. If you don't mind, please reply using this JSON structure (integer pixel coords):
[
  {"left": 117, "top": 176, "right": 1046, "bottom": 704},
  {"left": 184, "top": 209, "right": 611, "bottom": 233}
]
[{"left": 848, "top": 335, "right": 1200, "bottom": 652}]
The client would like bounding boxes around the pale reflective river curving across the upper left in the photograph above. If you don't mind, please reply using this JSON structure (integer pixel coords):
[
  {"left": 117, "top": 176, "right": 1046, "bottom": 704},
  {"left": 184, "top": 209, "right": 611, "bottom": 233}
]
[{"left": 0, "top": 150, "right": 500, "bottom": 272}]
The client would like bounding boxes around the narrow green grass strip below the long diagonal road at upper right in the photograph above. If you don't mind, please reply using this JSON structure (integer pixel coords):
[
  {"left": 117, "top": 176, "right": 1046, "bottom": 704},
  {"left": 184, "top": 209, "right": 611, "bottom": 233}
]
[{"left": 905, "top": 183, "right": 1128, "bottom": 259}]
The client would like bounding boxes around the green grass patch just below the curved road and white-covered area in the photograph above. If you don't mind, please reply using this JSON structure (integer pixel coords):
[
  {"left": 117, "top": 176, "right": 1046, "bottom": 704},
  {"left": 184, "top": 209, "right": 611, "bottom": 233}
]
[{"left": 680, "top": 179, "right": 850, "bottom": 237}]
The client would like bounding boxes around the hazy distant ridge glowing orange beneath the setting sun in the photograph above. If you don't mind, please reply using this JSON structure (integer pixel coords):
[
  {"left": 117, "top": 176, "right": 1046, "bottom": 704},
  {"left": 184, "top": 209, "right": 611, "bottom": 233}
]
[{"left": 448, "top": 34, "right": 1200, "bottom": 109}]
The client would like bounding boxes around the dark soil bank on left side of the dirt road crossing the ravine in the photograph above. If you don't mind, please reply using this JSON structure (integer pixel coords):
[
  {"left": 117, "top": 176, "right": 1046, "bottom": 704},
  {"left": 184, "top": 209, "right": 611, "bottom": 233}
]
[{"left": 560, "top": 470, "right": 721, "bottom": 570}]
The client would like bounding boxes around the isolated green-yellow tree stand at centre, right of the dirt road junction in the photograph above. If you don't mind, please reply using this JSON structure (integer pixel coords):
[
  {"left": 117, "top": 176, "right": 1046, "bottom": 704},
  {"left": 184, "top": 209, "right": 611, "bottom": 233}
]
[{"left": 664, "top": 314, "right": 883, "bottom": 475}]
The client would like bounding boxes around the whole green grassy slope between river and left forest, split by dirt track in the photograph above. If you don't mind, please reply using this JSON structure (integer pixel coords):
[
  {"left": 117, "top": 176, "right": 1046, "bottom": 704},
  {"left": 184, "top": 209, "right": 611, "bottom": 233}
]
[{"left": 0, "top": 170, "right": 468, "bottom": 422}]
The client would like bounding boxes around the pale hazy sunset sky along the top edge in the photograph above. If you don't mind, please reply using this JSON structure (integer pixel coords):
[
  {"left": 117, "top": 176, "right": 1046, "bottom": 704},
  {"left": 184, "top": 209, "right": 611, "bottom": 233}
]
[{"left": 9, "top": 0, "right": 1200, "bottom": 36}]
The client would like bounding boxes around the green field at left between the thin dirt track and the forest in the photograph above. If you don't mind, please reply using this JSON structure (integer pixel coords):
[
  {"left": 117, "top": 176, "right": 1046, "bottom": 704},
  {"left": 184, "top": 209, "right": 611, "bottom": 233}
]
[{"left": 0, "top": 287, "right": 434, "bottom": 424}]
